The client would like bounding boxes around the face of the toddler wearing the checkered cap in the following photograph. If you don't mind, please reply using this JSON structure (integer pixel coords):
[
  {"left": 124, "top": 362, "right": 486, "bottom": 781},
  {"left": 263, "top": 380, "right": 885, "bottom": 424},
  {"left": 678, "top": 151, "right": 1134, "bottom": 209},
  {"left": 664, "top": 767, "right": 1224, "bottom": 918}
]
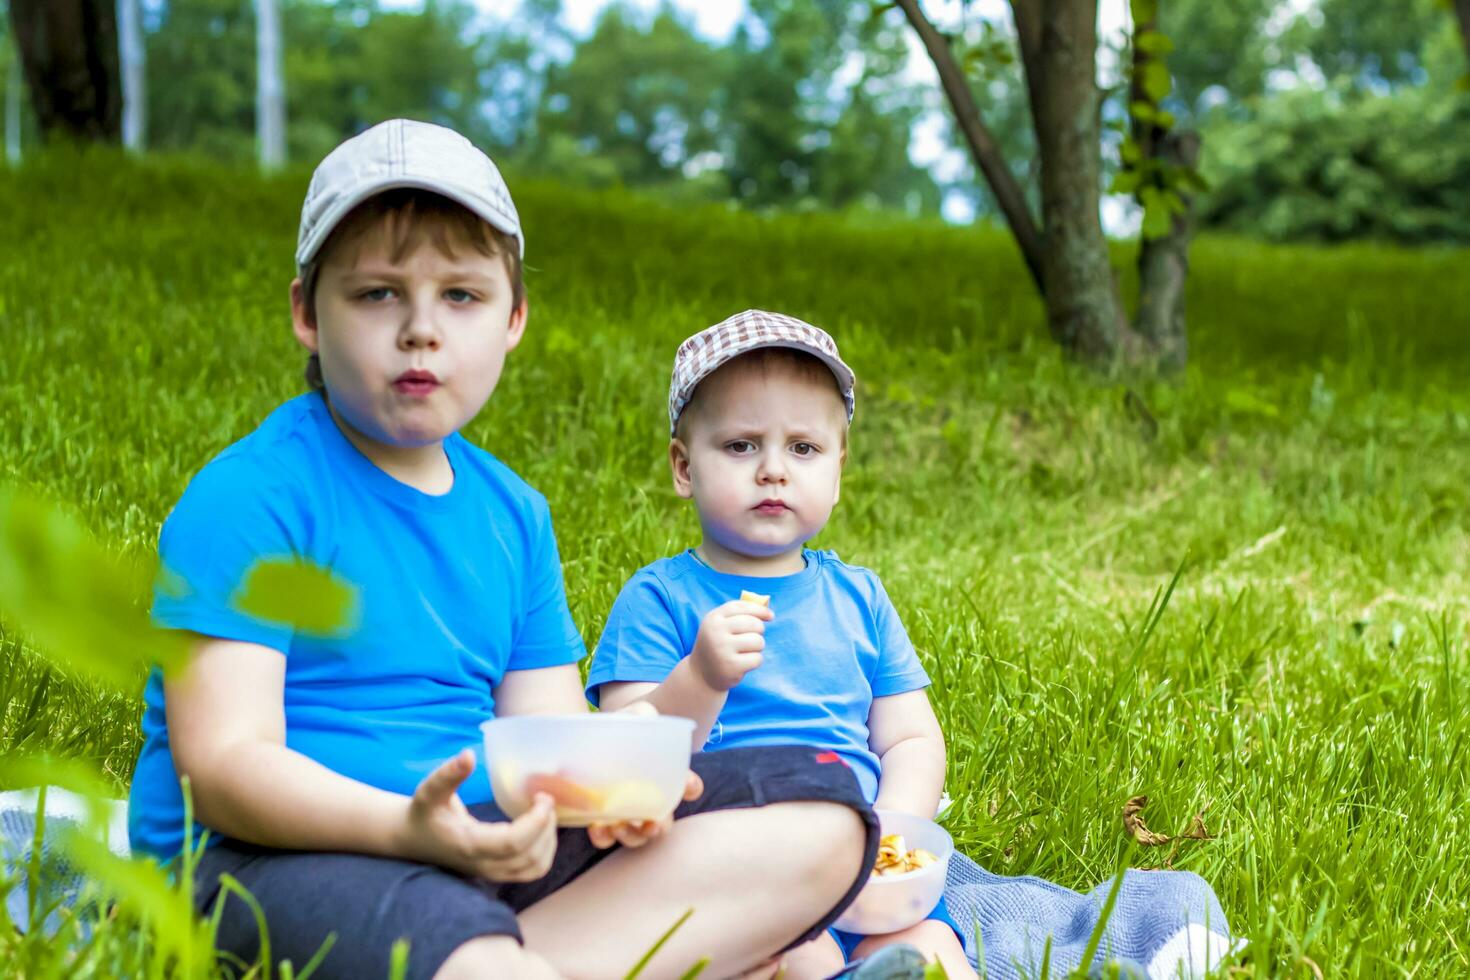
[{"left": 669, "top": 361, "right": 847, "bottom": 558}]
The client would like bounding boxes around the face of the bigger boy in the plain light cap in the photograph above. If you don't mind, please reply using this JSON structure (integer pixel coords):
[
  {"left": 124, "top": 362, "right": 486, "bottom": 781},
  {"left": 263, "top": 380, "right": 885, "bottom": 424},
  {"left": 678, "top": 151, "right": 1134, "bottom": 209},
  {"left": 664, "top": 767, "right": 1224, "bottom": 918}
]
[{"left": 291, "top": 228, "right": 526, "bottom": 455}]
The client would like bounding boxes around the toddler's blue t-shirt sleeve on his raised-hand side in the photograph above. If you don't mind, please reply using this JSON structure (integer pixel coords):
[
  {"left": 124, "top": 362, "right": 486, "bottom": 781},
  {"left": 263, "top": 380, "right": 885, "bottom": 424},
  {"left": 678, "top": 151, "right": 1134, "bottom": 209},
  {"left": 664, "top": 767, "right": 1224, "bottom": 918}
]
[{"left": 587, "top": 572, "right": 686, "bottom": 704}]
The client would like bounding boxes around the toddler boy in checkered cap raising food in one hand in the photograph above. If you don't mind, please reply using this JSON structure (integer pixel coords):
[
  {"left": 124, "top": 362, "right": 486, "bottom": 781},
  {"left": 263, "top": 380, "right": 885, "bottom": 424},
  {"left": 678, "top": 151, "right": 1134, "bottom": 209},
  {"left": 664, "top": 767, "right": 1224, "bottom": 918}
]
[{"left": 588, "top": 310, "right": 975, "bottom": 980}]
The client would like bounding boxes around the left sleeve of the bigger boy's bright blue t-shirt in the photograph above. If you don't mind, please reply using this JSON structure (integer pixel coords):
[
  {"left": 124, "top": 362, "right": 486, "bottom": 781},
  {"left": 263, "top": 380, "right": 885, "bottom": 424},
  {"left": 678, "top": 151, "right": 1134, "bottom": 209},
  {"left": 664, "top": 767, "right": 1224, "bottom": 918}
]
[{"left": 153, "top": 457, "right": 300, "bottom": 654}]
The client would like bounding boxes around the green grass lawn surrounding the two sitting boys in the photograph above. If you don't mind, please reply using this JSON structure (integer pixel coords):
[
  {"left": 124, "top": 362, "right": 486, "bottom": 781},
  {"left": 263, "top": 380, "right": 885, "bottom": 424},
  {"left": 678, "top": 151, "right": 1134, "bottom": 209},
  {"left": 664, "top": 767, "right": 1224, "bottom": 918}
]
[{"left": 0, "top": 147, "right": 1470, "bottom": 977}]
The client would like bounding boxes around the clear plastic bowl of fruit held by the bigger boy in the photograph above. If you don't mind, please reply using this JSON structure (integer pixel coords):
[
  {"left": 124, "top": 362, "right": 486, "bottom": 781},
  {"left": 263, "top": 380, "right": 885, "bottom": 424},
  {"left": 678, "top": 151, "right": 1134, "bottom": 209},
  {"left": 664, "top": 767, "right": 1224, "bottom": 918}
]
[{"left": 479, "top": 711, "right": 694, "bottom": 827}]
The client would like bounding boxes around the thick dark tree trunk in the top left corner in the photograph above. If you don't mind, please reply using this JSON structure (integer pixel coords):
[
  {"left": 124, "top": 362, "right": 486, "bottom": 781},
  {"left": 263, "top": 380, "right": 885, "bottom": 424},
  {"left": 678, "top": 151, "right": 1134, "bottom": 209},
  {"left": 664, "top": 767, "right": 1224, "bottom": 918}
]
[{"left": 10, "top": 0, "right": 122, "bottom": 143}]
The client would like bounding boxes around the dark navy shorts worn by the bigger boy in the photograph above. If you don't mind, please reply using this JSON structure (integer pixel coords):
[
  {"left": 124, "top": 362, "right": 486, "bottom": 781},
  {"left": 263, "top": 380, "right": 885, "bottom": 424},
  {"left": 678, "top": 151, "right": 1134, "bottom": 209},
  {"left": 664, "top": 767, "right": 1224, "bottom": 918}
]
[{"left": 194, "top": 745, "right": 878, "bottom": 979}]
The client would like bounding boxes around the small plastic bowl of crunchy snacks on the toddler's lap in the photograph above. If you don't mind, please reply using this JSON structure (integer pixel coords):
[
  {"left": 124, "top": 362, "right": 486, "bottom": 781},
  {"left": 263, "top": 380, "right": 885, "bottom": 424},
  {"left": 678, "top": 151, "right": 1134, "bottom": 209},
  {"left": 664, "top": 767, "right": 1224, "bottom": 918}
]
[{"left": 836, "top": 810, "right": 954, "bottom": 936}]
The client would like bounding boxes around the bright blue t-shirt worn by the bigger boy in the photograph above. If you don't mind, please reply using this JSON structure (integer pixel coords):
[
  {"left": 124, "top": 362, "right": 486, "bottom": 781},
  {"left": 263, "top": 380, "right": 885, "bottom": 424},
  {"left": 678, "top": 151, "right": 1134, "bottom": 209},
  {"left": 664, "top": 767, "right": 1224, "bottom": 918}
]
[{"left": 129, "top": 394, "right": 585, "bottom": 860}]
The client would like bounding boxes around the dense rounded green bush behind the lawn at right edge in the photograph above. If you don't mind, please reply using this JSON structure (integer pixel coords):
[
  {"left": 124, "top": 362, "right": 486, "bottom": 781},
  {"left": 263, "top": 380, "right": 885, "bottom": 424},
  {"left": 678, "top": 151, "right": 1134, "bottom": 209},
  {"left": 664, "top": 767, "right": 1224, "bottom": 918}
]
[{"left": 1200, "top": 85, "right": 1470, "bottom": 242}]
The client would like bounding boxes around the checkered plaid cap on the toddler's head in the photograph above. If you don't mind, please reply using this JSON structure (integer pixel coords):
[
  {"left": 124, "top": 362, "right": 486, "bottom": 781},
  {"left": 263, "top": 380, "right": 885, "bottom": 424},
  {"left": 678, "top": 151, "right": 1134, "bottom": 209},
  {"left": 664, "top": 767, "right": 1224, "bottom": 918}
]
[{"left": 669, "top": 310, "right": 857, "bottom": 435}]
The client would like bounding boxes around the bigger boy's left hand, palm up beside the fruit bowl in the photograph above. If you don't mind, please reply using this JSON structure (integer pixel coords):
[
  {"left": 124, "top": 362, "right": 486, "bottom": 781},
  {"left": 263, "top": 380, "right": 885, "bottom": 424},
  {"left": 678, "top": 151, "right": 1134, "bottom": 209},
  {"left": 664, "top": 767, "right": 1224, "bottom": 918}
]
[{"left": 403, "top": 749, "right": 556, "bottom": 882}]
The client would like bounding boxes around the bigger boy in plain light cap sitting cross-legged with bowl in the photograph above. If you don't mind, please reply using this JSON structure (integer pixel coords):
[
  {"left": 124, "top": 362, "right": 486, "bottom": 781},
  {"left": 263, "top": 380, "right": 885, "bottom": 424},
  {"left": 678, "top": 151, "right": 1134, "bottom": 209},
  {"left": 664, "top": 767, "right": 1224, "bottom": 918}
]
[{"left": 131, "top": 119, "right": 876, "bottom": 977}]
